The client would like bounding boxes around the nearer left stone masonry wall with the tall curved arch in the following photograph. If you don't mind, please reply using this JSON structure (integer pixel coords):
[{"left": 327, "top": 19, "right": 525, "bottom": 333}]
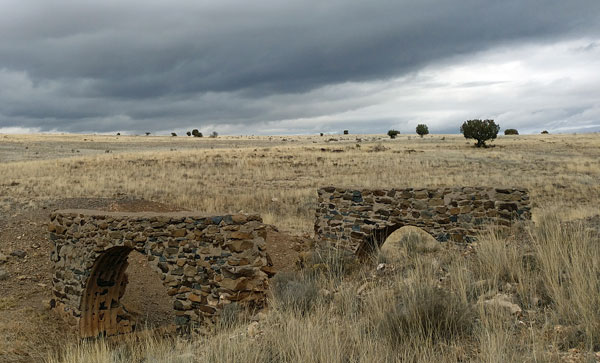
[{"left": 48, "top": 210, "right": 269, "bottom": 337}]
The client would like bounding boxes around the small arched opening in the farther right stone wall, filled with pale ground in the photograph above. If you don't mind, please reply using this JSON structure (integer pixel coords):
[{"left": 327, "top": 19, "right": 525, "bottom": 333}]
[{"left": 380, "top": 226, "right": 440, "bottom": 259}]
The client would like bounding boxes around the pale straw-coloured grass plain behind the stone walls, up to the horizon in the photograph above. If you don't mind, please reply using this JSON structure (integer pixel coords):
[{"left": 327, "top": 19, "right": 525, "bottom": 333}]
[{"left": 0, "top": 134, "right": 600, "bottom": 232}]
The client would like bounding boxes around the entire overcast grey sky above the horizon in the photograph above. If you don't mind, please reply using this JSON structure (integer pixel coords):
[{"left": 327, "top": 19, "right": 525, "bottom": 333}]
[{"left": 0, "top": 0, "right": 600, "bottom": 134}]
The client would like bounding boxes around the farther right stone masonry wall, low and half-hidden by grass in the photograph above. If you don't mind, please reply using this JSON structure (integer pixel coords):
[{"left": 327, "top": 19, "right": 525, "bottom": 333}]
[{"left": 315, "top": 187, "right": 531, "bottom": 253}]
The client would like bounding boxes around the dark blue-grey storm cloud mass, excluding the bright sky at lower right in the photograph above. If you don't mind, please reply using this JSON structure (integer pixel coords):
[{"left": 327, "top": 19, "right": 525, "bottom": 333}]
[{"left": 0, "top": 0, "right": 600, "bottom": 131}]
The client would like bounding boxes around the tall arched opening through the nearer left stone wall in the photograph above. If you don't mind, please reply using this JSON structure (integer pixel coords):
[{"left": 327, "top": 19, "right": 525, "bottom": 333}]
[{"left": 79, "top": 247, "right": 174, "bottom": 338}]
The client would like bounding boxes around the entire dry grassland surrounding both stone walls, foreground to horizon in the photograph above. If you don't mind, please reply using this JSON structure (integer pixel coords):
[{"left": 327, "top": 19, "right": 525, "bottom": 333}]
[{"left": 0, "top": 134, "right": 600, "bottom": 362}]
